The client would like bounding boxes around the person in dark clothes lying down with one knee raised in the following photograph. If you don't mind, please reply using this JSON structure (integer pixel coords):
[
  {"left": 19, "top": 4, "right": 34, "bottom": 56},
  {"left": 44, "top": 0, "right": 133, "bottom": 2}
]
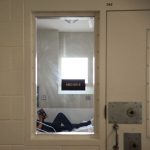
[{"left": 37, "top": 109, "right": 91, "bottom": 132}]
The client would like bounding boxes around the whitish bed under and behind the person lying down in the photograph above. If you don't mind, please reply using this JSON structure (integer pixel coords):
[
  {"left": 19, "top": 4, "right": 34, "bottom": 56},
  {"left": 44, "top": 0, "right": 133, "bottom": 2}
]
[{"left": 36, "top": 108, "right": 94, "bottom": 134}]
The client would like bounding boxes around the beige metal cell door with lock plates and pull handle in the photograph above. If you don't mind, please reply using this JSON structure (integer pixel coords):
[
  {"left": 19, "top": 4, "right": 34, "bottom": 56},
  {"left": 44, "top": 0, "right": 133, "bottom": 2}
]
[{"left": 107, "top": 11, "right": 150, "bottom": 150}]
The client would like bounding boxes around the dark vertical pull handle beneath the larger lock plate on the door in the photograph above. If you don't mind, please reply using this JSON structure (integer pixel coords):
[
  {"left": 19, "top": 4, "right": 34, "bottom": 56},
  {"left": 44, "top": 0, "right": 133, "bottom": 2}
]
[{"left": 113, "top": 123, "right": 119, "bottom": 150}]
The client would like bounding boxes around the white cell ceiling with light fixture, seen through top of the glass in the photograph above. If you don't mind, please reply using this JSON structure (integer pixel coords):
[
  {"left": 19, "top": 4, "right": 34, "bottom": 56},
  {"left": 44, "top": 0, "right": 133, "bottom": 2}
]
[{"left": 37, "top": 17, "right": 94, "bottom": 32}]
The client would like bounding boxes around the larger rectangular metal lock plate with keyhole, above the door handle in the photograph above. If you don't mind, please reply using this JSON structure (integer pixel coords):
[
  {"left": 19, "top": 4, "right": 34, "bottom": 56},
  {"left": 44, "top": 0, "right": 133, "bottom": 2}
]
[{"left": 108, "top": 102, "right": 142, "bottom": 124}]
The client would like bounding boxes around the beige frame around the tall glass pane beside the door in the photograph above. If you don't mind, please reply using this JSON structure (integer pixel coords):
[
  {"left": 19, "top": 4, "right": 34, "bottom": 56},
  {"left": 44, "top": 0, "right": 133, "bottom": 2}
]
[{"left": 30, "top": 11, "right": 100, "bottom": 145}]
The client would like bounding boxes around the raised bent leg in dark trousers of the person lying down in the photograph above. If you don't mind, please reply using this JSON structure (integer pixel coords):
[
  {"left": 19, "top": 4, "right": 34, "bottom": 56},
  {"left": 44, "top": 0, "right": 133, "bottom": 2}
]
[{"left": 52, "top": 113, "right": 73, "bottom": 131}]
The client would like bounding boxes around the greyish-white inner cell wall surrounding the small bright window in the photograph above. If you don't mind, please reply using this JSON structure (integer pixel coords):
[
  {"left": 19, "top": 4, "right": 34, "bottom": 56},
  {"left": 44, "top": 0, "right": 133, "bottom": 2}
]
[{"left": 37, "top": 29, "right": 94, "bottom": 108}]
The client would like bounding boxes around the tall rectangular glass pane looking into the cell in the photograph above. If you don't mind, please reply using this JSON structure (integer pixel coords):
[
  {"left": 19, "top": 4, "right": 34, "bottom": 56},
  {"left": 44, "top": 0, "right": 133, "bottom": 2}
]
[{"left": 36, "top": 17, "right": 95, "bottom": 134}]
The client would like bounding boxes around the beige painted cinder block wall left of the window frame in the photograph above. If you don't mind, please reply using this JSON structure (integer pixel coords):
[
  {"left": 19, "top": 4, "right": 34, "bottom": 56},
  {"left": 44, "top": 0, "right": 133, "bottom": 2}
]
[{"left": 0, "top": 0, "right": 25, "bottom": 150}]
